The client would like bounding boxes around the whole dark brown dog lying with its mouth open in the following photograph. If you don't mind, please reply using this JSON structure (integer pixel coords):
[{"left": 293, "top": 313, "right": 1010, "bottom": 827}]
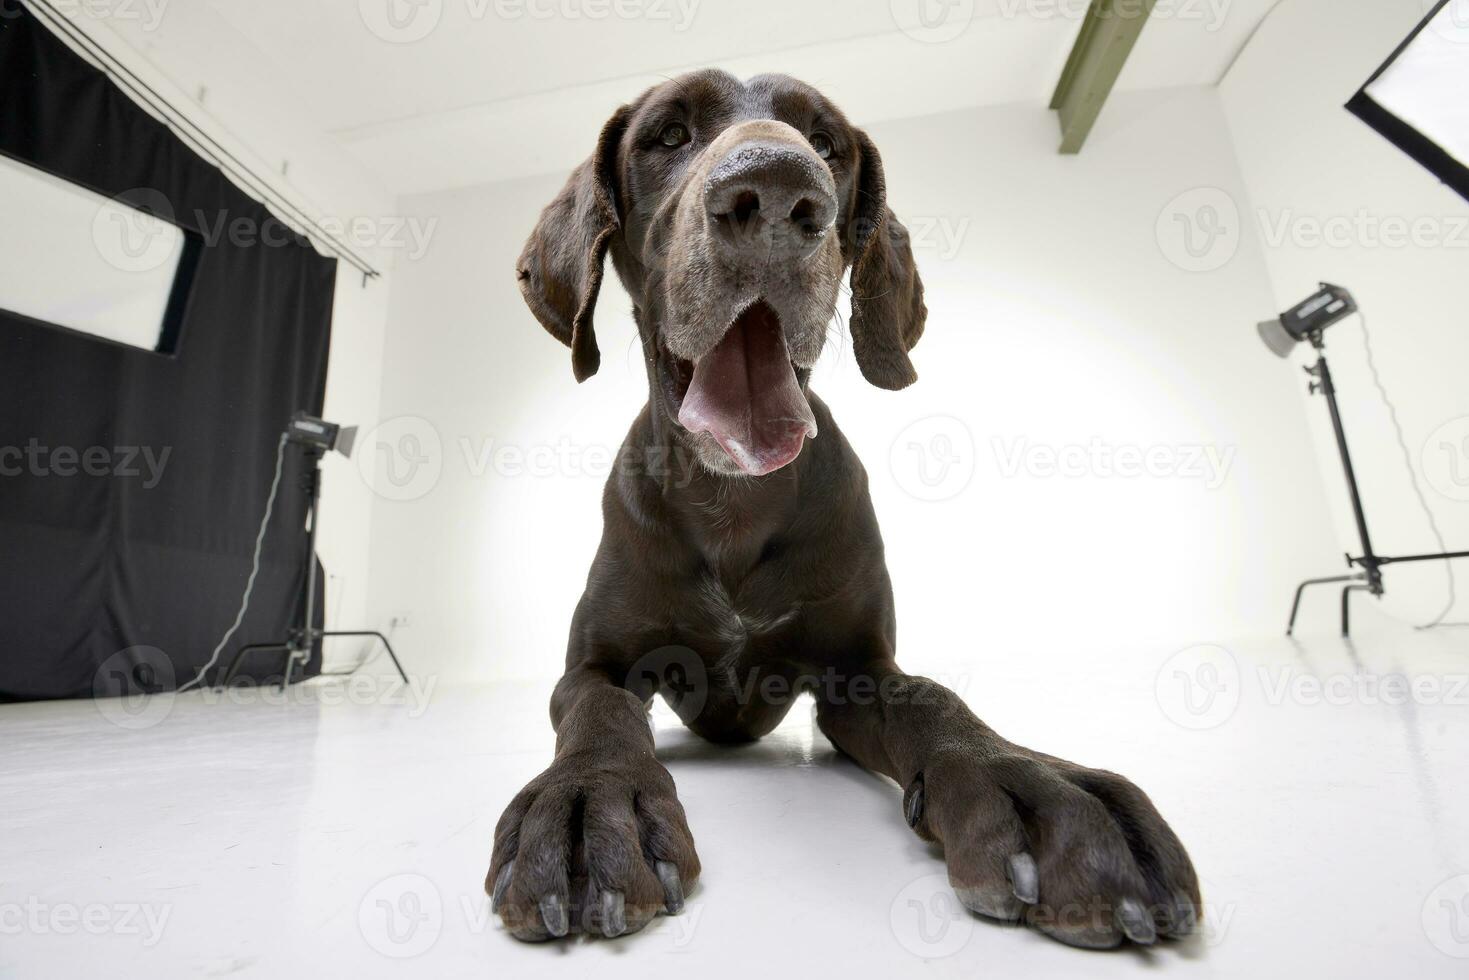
[{"left": 486, "top": 71, "right": 1200, "bottom": 948}]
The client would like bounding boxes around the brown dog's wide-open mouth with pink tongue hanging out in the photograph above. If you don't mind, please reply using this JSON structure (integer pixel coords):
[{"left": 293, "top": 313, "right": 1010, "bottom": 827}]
[{"left": 679, "top": 303, "right": 817, "bottom": 476}]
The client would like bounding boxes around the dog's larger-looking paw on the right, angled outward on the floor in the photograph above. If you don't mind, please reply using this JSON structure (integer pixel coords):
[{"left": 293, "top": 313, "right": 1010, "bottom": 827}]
[{"left": 903, "top": 752, "right": 1202, "bottom": 949}]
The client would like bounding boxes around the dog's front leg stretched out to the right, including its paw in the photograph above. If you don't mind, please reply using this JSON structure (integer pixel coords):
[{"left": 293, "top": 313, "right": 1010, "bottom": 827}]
[{"left": 817, "top": 666, "right": 1202, "bottom": 948}]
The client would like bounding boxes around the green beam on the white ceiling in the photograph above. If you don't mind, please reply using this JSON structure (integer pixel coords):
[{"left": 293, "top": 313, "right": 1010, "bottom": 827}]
[{"left": 1050, "top": 0, "right": 1158, "bottom": 153}]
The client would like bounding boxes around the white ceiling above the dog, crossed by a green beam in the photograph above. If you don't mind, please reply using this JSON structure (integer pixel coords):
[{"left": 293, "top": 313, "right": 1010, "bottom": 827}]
[{"left": 123, "top": 0, "right": 1274, "bottom": 194}]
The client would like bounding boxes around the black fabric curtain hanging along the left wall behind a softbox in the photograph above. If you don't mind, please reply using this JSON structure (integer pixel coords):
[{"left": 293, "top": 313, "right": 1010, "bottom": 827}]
[{"left": 0, "top": 1, "right": 336, "bottom": 701}]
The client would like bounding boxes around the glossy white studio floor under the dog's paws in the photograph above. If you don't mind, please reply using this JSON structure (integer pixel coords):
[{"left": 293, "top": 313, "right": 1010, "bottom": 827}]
[{"left": 0, "top": 617, "right": 1469, "bottom": 980}]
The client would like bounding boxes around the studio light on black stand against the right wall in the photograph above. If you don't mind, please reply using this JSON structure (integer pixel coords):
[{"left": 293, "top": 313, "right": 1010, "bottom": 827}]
[{"left": 1260, "top": 284, "right": 1469, "bottom": 636}]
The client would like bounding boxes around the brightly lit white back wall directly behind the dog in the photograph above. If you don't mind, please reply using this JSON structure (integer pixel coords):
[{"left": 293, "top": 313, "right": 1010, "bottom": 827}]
[{"left": 372, "top": 88, "right": 1334, "bottom": 679}]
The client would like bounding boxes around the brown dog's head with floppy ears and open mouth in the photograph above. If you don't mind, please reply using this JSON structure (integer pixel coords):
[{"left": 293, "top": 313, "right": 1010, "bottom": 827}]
[{"left": 516, "top": 71, "right": 927, "bottom": 476}]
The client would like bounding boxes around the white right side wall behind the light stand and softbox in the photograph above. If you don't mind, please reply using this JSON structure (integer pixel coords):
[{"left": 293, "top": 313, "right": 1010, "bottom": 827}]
[{"left": 1221, "top": 0, "right": 1469, "bottom": 621}]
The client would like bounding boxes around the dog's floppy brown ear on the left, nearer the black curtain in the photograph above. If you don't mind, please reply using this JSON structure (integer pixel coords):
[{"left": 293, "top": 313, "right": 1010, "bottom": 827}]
[{"left": 516, "top": 106, "right": 630, "bottom": 381}]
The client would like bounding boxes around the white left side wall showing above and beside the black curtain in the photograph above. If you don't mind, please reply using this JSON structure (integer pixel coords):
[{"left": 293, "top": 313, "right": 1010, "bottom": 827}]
[{"left": 49, "top": 3, "right": 402, "bottom": 660}]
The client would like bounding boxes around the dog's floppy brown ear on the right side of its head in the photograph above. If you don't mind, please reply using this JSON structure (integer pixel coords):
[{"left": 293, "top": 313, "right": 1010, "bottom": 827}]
[{"left": 842, "top": 129, "right": 928, "bottom": 391}]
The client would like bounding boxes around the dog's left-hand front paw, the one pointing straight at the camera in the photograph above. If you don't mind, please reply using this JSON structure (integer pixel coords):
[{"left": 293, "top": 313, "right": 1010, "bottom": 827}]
[{"left": 485, "top": 754, "right": 699, "bottom": 940}]
